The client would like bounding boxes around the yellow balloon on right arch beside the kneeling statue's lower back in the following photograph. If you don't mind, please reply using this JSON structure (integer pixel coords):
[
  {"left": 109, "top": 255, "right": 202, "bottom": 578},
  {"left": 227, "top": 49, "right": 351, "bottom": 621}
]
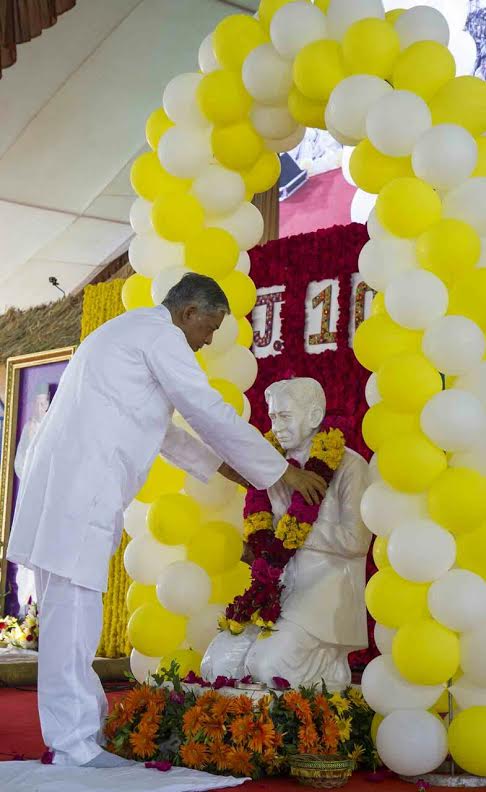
[{"left": 365, "top": 567, "right": 429, "bottom": 629}]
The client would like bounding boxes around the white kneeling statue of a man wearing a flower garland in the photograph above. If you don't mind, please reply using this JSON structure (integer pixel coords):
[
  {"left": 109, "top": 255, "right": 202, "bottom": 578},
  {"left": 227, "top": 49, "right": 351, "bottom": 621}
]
[{"left": 202, "top": 378, "right": 370, "bottom": 690}]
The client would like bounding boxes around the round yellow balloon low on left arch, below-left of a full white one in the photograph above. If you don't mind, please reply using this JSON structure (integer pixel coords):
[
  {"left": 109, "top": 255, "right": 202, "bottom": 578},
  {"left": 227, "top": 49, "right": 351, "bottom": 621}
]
[{"left": 127, "top": 603, "right": 186, "bottom": 657}]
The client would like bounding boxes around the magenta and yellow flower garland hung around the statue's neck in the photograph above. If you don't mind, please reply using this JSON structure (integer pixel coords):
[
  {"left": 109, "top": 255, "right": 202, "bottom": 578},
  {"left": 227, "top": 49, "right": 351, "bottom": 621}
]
[{"left": 219, "top": 429, "right": 345, "bottom": 637}]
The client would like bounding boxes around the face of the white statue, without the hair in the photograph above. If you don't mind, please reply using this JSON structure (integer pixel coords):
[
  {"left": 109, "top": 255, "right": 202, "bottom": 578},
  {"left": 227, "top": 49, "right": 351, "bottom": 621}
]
[{"left": 268, "top": 391, "right": 315, "bottom": 451}]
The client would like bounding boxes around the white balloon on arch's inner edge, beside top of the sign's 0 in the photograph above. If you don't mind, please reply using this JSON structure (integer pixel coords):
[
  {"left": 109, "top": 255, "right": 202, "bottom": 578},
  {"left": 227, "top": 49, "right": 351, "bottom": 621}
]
[{"left": 358, "top": 237, "right": 418, "bottom": 293}]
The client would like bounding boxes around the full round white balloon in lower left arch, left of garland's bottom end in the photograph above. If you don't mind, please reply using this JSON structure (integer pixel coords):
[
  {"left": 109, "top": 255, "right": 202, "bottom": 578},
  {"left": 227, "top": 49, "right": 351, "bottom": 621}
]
[{"left": 157, "top": 561, "right": 211, "bottom": 616}]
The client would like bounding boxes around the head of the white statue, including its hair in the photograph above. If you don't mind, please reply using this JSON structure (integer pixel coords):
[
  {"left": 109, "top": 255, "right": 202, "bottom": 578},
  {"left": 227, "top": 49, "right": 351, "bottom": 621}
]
[{"left": 265, "top": 377, "right": 326, "bottom": 451}]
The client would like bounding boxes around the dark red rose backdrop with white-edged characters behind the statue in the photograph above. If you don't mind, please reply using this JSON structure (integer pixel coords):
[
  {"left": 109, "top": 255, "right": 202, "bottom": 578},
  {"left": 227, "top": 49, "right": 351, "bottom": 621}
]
[{"left": 247, "top": 223, "right": 377, "bottom": 668}]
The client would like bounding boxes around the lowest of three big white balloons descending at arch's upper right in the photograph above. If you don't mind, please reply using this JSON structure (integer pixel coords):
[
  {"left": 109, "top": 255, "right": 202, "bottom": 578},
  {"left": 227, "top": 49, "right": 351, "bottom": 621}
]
[{"left": 412, "top": 124, "right": 478, "bottom": 190}]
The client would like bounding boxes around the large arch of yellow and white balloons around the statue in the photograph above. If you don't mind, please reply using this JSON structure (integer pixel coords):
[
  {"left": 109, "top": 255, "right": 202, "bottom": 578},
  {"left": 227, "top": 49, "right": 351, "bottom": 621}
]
[{"left": 123, "top": 0, "right": 486, "bottom": 775}]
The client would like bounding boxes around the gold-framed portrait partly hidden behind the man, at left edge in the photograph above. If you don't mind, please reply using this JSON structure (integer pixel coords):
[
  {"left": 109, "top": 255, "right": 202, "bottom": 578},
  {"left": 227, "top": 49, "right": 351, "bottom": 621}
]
[{"left": 0, "top": 347, "right": 75, "bottom": 616}]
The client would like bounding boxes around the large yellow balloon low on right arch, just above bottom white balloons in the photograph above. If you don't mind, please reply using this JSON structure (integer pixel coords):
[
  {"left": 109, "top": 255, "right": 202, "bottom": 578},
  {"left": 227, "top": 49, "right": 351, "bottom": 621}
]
[{"left": 392, "top": 618, "right": 460, "bottom": 685}]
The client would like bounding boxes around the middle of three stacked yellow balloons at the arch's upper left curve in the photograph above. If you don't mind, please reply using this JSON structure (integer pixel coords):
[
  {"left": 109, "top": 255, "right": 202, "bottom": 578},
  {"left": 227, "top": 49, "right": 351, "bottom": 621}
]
[{"left": 197, "top": 69, "right": 252, "bottom": 125}]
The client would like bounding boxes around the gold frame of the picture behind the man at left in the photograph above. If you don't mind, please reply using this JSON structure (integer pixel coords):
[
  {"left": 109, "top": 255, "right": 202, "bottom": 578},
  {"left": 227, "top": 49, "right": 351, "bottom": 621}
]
[{"left": 0, "top": 346, "right": 76, "bottom": 614}]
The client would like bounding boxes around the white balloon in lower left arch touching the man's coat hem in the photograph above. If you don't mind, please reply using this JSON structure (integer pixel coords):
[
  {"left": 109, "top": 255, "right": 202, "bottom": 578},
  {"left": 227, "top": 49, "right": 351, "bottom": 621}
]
[{"left": 123, "top": 533, "right": 186, "bottom": 586}]
